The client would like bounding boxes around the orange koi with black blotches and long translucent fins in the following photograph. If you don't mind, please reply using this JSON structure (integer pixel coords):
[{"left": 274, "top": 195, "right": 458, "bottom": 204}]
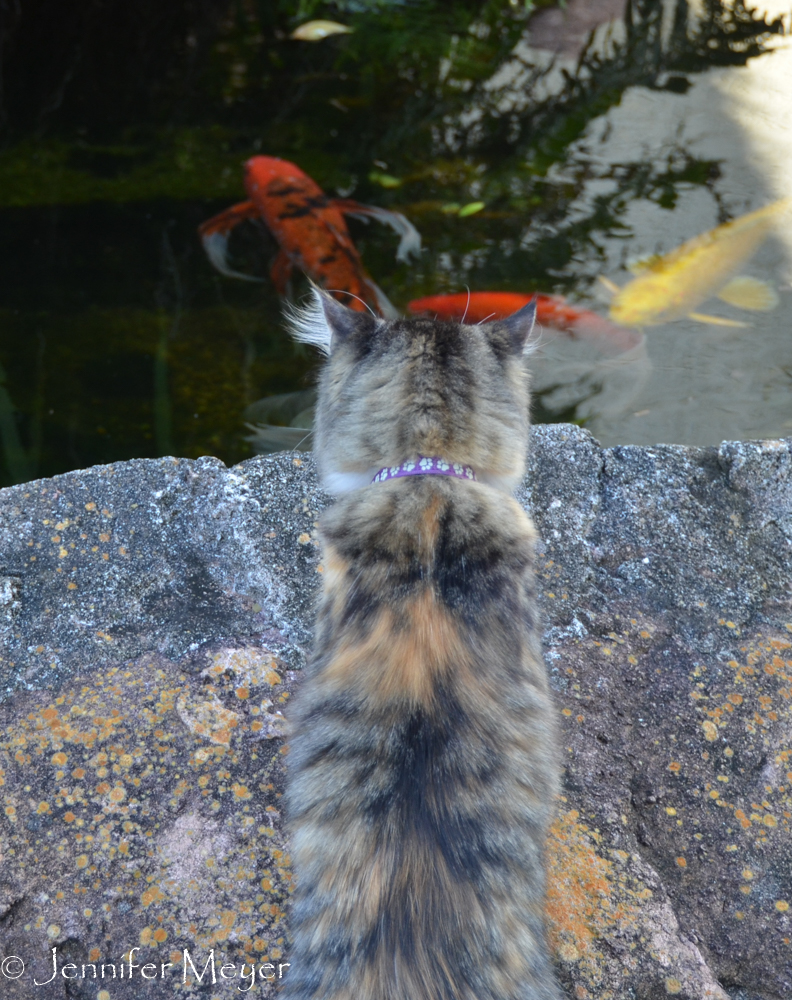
[{"left": 198, "top": 156, "right": 421, "bottom": 317}]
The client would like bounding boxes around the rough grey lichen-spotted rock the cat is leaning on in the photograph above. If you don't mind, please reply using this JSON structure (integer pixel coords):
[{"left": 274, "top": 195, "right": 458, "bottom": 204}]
[{"left": 0, "top": 425, "right": 792, "bottom": 1000}]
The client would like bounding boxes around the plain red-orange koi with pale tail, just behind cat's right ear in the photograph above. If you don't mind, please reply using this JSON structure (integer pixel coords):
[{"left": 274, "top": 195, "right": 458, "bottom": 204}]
[{"left": 407, "top": 292, "right": 643, "bottom": 353}]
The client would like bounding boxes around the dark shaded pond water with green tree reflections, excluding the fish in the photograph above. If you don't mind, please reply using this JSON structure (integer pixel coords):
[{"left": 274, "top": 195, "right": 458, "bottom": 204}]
[{"left": 0, "top": 0, "right": 782, "bottom": 484}]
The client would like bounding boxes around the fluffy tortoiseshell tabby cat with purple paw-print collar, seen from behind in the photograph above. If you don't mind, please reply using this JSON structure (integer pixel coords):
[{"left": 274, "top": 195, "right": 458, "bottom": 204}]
[{"left": 282, "top": 289, "right": 561, "bottom": 1000}]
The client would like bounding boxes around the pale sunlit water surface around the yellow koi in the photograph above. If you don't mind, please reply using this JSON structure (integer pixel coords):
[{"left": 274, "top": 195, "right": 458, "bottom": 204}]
[{"left": 536, "top": 7, "right": 792, "bottom": 444}]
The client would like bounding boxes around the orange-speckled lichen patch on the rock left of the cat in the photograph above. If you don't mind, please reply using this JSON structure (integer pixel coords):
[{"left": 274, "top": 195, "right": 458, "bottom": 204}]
[{"left": 0, "top": 649, "right": 292, "bottom": 984}]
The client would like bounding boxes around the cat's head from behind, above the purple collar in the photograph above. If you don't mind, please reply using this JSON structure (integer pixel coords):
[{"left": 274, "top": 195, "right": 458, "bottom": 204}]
[{"left": 291, "top": 289, "right": 535, "bottom": 493}]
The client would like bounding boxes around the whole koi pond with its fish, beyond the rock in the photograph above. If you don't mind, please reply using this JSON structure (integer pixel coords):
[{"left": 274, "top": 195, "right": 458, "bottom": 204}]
[{"left": 0, "top": 0, "right": 792, "bottom": 485}]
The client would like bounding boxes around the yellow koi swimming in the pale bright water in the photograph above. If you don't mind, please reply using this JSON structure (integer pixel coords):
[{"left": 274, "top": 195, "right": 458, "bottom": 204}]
[{"left": 600, "top": 198, "right": 792, "bottom": 327}]
